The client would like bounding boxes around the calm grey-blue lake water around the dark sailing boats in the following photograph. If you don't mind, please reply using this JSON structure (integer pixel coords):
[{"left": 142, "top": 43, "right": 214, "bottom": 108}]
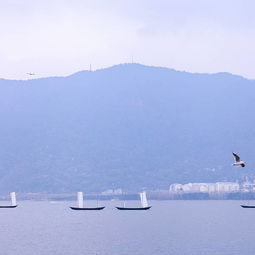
[{"left": 0, "top": 201, "right": 255, "bottom": 255}]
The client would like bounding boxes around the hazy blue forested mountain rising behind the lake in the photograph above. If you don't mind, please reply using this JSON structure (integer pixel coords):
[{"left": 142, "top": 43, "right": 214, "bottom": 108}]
[{"left": 0, "top": 64, "right": 255, "bottom": 192}]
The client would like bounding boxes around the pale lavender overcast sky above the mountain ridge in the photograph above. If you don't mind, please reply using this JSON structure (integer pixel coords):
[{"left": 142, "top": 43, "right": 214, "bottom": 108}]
[{"left": 0, "top": 0, "right": 255, "bottom": 79}]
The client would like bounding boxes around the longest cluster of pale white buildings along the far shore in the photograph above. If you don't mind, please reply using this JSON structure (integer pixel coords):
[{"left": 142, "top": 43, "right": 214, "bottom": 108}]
[{"left": 169, "top": 182, "right": 239, "bottom": 193}]
